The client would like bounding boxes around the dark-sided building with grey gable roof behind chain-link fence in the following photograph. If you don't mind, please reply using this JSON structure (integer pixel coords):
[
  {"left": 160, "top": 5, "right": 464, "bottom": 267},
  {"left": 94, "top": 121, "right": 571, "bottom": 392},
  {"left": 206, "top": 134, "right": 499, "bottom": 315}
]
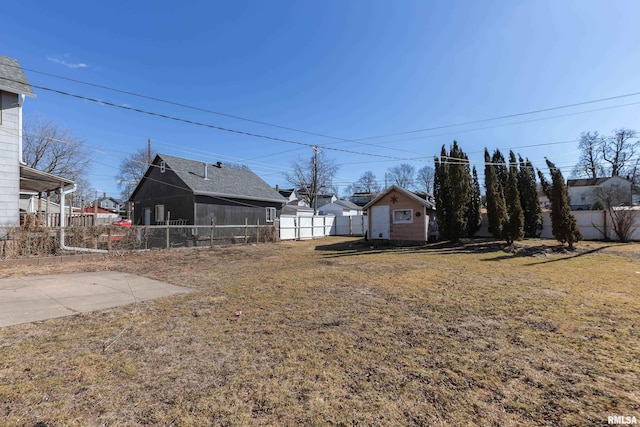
[{"left": 130, "top": 154, "right": 286, "bottom": 225}]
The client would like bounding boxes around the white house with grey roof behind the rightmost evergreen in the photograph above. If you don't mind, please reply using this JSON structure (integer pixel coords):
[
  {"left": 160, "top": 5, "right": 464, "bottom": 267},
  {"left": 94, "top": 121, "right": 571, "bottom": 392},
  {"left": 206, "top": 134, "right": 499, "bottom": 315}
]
[{"left": 567, "top": 176, "right": 632, "bottom": 211}]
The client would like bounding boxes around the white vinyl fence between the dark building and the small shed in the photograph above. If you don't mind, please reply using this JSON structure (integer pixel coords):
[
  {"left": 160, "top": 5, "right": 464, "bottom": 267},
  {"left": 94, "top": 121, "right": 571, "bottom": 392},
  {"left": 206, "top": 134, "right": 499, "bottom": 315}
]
[{"left": 280, "top": 215, "right": 367, "bottom": 240}]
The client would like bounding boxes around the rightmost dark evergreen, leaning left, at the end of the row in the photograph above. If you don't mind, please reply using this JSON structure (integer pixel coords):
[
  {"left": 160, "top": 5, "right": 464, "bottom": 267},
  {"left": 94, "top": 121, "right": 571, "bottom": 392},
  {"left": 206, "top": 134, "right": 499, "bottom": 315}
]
[{"left": 538, "top": 159, "right": 582, "bottom": 250}]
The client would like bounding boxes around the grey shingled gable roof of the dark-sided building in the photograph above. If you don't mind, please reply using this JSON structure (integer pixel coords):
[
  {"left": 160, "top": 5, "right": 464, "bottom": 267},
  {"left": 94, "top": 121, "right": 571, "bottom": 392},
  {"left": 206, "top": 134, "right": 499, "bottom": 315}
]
[{"left": 131, "top": 154, "right": 287, "bottom": 205}]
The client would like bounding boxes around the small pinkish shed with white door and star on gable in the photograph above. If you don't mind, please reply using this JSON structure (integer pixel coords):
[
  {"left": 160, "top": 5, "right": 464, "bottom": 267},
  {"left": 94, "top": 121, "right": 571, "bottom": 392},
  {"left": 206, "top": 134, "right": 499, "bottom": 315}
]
[{"left": 363, "top": 185, "right": 435, "bottom": 242}]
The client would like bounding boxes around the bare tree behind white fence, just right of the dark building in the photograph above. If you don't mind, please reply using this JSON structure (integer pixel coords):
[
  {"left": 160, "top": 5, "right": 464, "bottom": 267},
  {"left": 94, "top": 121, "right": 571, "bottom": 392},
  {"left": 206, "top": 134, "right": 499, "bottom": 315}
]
[{"left": 285, "top": 152, "right": 340, "bottom": 213}]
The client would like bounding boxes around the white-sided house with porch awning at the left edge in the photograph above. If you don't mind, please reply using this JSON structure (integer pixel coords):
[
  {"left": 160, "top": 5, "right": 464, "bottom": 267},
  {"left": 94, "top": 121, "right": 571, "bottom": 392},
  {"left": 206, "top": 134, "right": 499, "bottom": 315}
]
[{"left": 0, "top": 56, "right": 73, "bottom": 227}]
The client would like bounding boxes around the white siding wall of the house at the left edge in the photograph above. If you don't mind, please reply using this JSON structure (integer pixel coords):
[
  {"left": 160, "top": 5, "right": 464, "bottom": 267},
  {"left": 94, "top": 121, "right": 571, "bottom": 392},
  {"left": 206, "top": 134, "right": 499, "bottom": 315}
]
[{"left": 0, "top": 91, "right": 20, "bottom": 227}]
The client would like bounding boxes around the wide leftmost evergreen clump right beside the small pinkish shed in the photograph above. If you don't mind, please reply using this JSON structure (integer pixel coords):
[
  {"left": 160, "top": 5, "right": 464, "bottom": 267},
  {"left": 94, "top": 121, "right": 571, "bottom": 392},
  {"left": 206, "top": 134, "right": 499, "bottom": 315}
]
[{"left": 434, "top": 141, "right": 471, "bottom": 242}]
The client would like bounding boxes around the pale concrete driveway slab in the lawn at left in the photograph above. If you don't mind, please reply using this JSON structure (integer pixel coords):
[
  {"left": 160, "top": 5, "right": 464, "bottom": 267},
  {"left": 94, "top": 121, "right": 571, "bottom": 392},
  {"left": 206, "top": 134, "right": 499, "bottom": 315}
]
[{"left": 0, "top": 271, "right": 192, "bottom": 327}]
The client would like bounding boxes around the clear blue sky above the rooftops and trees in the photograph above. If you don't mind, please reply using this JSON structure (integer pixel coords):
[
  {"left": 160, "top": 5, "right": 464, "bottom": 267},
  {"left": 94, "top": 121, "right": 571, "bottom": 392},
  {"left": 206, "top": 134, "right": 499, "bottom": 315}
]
[{"left": 0, "top": 0, "right": 640, "bottom": 199}]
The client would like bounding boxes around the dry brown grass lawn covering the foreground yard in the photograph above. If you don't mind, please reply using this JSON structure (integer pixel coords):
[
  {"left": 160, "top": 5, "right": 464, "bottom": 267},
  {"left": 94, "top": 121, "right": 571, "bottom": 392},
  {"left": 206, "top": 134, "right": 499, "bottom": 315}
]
[{"left": 0, "top": 238, "right": 640, "bottom": 426}]
